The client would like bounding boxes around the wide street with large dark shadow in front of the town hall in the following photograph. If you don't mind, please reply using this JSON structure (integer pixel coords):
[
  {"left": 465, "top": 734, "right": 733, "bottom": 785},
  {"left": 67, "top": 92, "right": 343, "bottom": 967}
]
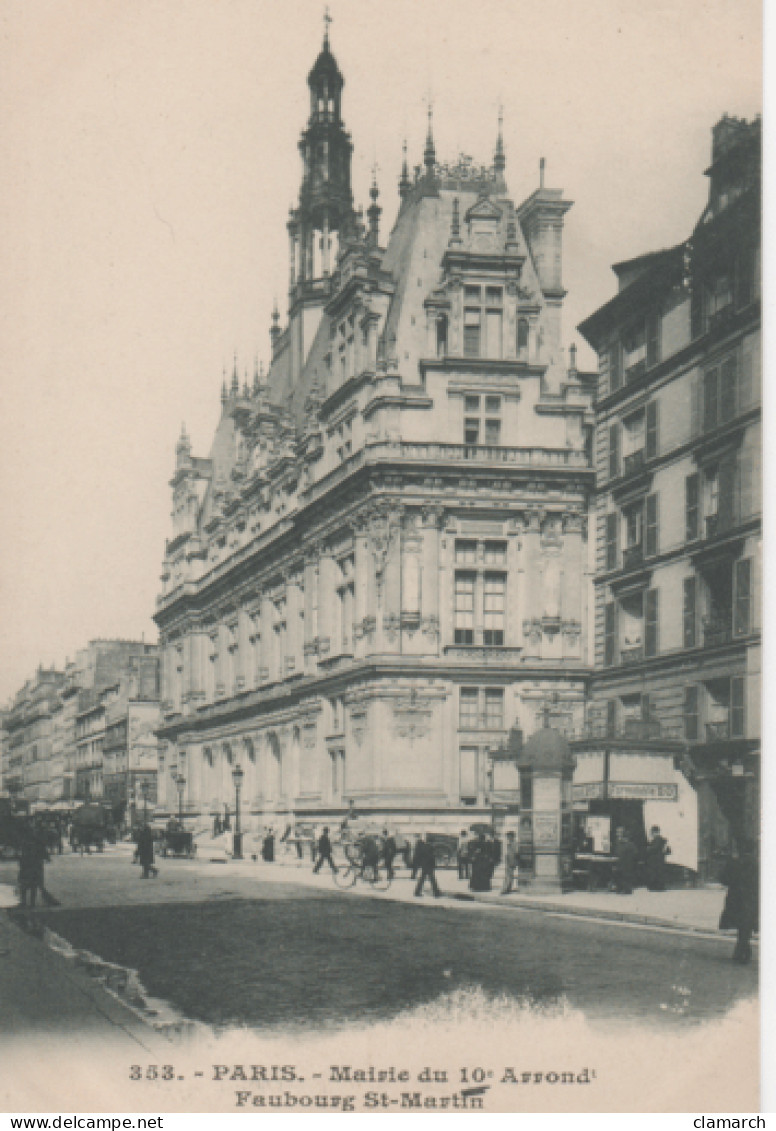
[{"left": 0, "top": 846, "right": 757, "bottom": 1030}]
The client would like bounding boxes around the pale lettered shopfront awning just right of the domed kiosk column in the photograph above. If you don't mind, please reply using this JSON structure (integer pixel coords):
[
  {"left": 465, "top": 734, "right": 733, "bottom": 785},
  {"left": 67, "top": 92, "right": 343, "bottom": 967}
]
[{"left": 572, "top": 750, "right": 679, "bottom": 802}]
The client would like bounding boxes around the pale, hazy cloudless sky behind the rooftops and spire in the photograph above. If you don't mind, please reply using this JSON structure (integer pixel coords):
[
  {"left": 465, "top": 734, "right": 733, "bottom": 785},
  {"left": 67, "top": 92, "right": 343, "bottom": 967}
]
[{"left": 0, "top": 0, "right": 761, "bottom": 705}]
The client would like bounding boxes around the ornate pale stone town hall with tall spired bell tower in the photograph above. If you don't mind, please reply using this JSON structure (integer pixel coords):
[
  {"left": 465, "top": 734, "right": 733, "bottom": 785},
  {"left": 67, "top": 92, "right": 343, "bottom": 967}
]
[{"left": 155, "top": 30, "right": 594, "bottom": 828}]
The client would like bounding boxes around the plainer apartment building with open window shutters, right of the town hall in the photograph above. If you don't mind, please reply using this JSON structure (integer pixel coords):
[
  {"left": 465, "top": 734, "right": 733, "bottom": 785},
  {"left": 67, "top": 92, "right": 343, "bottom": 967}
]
[{"left": 576, "top": 116, "right": 762, "bottom": 878}]
